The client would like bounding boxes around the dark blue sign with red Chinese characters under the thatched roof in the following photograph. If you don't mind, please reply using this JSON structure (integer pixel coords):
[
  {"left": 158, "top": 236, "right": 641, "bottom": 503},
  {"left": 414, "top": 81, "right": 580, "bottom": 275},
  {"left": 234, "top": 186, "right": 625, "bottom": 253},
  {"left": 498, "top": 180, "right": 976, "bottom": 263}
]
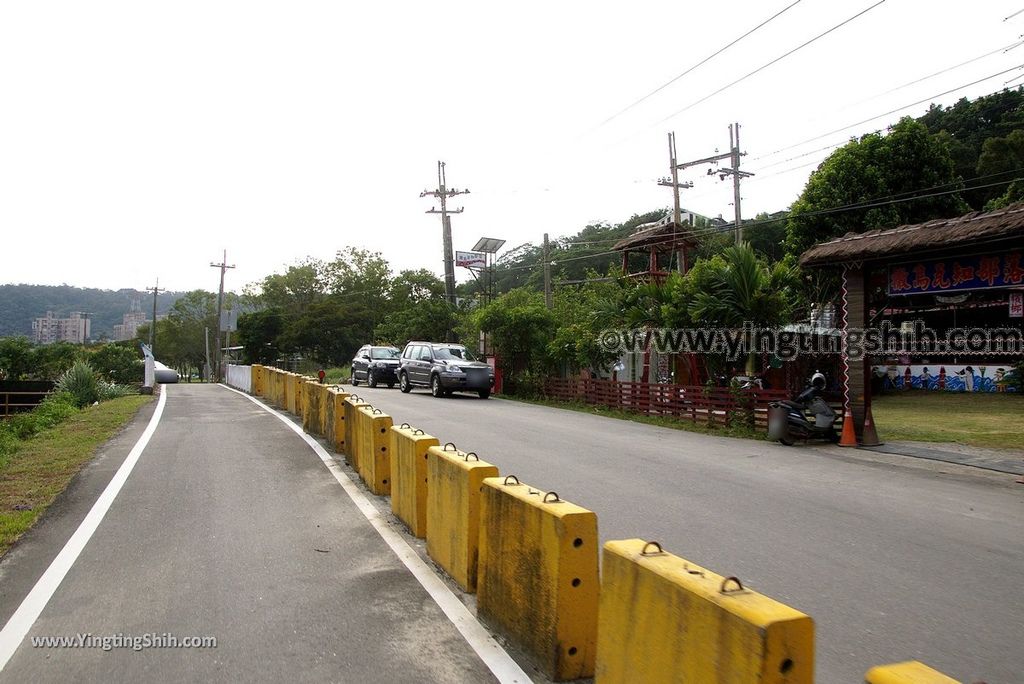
[{"left": 889, "top": 251, "right": 1024, "bottom": 295}]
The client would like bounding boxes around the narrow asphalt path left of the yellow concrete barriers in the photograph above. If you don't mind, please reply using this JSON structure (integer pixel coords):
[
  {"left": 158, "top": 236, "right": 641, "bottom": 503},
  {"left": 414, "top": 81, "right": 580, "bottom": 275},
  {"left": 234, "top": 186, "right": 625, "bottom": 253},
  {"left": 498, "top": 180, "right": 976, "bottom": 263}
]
[{"left": 0, "top": 385, "right": 503, "bottom": 682}]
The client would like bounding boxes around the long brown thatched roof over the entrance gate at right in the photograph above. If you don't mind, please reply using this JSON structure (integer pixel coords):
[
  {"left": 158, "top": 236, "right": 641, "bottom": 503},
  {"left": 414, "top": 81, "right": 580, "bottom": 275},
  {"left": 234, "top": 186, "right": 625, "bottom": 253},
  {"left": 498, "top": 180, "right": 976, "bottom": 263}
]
[{"left": 800, "top": 203, "right": 1024, "bottom": 266}]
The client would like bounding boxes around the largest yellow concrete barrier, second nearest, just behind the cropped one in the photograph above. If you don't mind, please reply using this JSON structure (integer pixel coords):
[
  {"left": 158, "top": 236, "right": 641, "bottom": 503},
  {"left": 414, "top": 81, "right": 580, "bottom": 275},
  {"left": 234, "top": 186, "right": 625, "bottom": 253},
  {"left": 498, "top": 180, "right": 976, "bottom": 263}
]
[{"left": 594, "top": 540, "right": 814, "bottom": 684}]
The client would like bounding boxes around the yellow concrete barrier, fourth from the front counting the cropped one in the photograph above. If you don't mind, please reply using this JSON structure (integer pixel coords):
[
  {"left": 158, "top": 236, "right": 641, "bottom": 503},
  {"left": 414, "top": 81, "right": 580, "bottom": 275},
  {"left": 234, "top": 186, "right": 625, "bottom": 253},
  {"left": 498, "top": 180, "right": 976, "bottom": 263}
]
[{"left": 427, "top": 442, "right": 498, "bottom": 594}]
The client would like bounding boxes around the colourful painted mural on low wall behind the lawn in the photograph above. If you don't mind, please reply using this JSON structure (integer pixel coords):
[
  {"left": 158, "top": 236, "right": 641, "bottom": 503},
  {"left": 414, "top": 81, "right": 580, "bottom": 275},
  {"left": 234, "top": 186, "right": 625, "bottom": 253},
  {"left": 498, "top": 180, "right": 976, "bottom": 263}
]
[{"left": 871, "top": 362, "right": 1015, "bottom": 392}]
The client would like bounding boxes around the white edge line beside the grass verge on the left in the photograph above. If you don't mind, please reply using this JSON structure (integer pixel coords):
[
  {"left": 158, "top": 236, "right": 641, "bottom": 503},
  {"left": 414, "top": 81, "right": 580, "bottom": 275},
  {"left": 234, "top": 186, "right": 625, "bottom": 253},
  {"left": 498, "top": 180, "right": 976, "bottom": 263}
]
[{"left": 0, "top": 385, "right": 167, "bottom": 671}]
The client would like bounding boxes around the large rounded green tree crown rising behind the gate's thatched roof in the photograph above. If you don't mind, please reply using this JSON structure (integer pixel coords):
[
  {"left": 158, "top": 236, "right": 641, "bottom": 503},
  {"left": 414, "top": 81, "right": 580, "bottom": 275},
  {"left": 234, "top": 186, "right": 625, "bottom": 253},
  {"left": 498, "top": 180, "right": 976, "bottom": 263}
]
[{"left": 785, "top": 118, "right": 968, "bottom": 256}]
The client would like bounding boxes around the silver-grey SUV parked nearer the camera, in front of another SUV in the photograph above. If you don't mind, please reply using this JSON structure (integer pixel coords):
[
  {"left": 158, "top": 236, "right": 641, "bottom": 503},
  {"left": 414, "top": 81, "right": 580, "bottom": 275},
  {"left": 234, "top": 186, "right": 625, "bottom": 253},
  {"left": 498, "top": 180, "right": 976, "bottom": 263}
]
[{"left": 398, "top": 342, "right": 495, "bottom": 399}]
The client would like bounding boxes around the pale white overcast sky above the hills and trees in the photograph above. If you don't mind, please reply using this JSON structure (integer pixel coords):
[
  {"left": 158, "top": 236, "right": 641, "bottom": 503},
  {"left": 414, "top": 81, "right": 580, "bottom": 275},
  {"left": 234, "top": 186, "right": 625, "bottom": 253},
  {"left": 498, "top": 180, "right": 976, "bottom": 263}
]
[{"left": 0, "top": 0, "right": 1024, "bottom": 291}]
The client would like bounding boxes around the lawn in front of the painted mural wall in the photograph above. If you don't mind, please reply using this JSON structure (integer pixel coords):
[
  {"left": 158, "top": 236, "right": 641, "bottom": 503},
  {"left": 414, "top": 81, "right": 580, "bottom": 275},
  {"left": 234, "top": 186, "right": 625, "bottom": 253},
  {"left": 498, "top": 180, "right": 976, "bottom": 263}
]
[{"left": 871, "top": 391, "right": 1024, "bottom": 450}]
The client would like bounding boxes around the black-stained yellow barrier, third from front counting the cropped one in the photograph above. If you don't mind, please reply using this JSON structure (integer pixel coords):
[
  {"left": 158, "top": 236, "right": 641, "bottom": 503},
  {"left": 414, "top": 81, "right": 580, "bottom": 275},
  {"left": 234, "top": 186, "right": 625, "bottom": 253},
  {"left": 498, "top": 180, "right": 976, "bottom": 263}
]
[{"left": 476, "top": 475, "right": 598, "bottom": 682}]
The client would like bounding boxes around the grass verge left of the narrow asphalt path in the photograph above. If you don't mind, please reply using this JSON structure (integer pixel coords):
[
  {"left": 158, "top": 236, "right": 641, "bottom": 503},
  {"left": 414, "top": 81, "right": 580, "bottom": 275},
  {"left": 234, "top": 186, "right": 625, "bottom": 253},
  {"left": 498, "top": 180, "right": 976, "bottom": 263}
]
[{"left": 0, "top": 395, "right": 154, "bottom": 556}]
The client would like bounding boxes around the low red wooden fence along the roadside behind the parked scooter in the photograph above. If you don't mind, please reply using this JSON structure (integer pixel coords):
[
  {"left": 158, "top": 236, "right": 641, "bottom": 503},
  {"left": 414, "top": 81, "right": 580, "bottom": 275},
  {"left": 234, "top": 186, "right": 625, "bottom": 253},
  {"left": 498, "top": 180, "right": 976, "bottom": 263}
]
[{"left": 545, "top": 378, "right": 788, "bottom": 429}]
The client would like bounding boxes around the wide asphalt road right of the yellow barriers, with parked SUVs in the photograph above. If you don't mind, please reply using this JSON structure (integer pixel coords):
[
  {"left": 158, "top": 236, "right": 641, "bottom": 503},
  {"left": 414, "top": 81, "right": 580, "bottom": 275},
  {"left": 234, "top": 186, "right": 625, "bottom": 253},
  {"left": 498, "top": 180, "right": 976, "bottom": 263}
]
[{"left": 349, "top": 386, "right": 1024, "bottom": 684}]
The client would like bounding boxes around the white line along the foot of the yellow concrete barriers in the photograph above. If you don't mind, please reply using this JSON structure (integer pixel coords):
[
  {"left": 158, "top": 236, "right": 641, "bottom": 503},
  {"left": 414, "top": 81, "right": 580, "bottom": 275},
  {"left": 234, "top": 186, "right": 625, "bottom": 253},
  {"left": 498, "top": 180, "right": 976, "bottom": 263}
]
[{"left": 221, "top": 385, "right": 532, "bottom": 684}]
